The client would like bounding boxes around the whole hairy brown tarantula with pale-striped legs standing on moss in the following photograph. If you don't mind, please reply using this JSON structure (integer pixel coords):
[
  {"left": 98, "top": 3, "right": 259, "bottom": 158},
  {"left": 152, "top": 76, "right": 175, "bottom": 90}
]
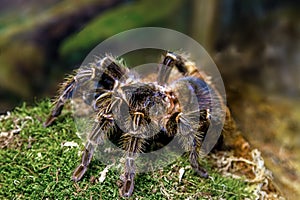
[{"left": 44, "top": 52, "right": 226, "bottom": 197}]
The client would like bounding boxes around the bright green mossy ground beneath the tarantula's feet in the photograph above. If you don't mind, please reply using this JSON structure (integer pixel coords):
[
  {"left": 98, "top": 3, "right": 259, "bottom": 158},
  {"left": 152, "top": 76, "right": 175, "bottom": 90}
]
[{"left": 0, "top": 100, "right": 253, "bottom": 199}]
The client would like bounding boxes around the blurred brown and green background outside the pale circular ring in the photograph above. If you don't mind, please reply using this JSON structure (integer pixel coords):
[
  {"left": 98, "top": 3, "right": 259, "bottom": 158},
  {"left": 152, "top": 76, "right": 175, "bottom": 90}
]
[{"left": 0, "top": 0, "right": 300, "bottom": 199}]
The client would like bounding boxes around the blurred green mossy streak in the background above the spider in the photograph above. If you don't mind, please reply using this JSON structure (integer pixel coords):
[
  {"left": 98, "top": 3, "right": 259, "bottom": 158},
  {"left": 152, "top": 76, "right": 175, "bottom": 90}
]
[{"left": 60, "top": 0, "right": 183, "bottom": 56}]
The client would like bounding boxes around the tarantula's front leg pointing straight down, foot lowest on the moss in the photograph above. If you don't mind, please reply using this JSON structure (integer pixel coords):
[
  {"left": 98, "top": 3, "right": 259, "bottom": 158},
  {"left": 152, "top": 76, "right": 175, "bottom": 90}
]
[{"left": 120, "top": 134, "right": 145, "bottom": 197}]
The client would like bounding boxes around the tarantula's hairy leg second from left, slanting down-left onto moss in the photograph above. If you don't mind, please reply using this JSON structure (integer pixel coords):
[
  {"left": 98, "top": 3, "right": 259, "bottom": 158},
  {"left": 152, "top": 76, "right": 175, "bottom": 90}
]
[{"left": 72, "top": 118, "right": 112, "bottom": 182}]
